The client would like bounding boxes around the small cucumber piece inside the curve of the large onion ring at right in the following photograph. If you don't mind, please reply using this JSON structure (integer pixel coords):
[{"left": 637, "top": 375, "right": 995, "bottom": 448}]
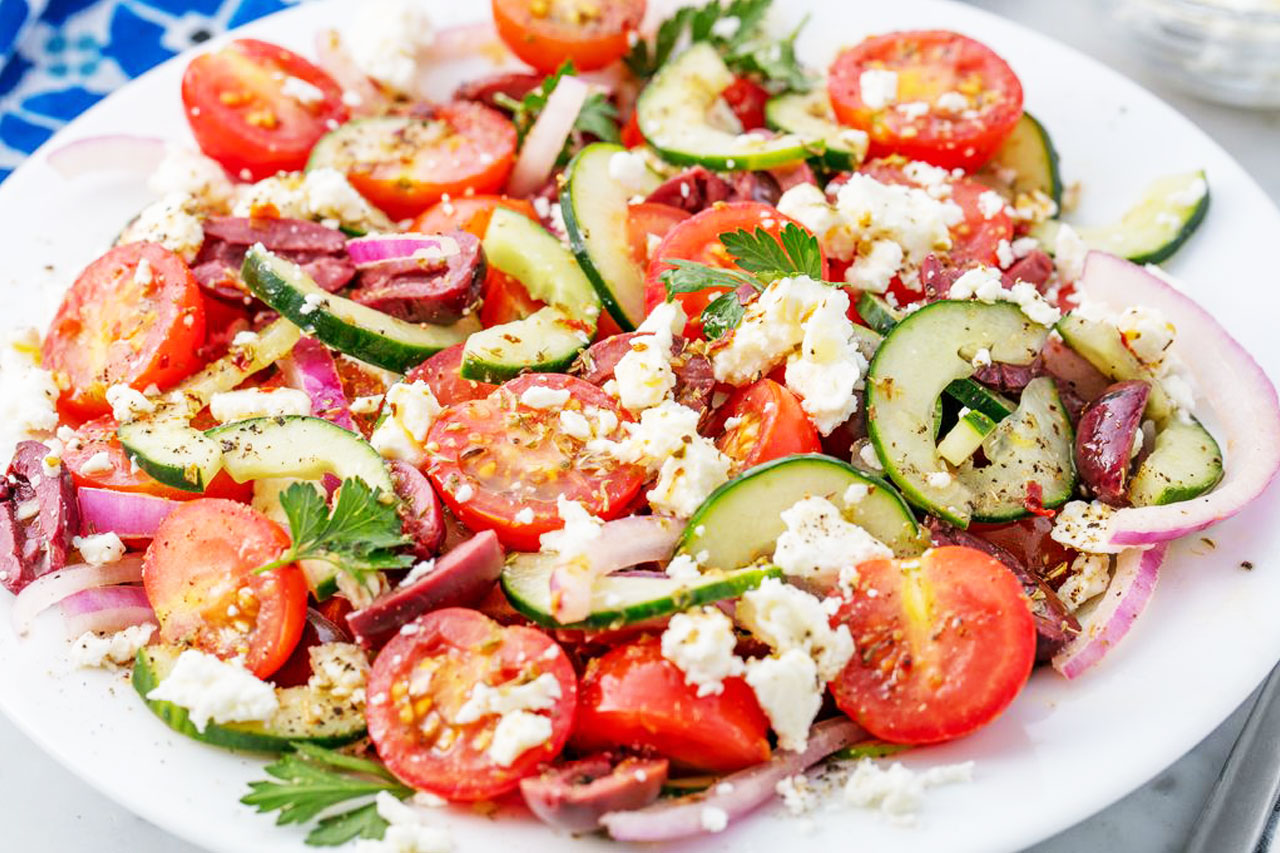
[{"left": 1129, "top": 418, "right": 1222, "bottom": 506}]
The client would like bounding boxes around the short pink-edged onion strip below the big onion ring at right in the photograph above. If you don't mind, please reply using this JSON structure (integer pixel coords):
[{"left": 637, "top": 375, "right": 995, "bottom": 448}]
[{"left": 1053, "top": 542, "right": 1169, "bottom": 679}]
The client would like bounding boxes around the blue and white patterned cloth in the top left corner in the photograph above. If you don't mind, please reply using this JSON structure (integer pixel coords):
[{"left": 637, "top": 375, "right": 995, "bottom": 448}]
[{"left": 0, "top": 0, "right": 304, "bottom": 181}]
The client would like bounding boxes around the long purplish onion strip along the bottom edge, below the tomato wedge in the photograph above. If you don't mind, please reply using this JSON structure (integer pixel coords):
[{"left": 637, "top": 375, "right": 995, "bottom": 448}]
[{"left": 600, "top": 719, "right": 867, "bottom": 841}]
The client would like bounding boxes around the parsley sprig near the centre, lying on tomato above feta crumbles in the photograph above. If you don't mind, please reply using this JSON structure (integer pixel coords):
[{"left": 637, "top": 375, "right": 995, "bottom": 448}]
[{"left": 660, "top": 223, "right": 822, "bottom": 341}]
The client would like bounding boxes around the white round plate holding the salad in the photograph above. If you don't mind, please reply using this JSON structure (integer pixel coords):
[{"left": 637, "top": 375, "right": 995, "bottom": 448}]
[{"left": 0, "top": 0, "right": 1280, "bottom": 853}]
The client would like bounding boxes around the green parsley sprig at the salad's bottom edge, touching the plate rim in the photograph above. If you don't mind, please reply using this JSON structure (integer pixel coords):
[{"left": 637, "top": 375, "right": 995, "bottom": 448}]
[{"left": 241, "top": 743, "right": 413, "bottom": 847}]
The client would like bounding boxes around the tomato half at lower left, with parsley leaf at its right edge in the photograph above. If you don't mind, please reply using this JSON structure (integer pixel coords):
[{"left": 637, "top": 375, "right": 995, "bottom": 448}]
[{"left": 142, "top": 498, "right": 307, "bottom": 679}]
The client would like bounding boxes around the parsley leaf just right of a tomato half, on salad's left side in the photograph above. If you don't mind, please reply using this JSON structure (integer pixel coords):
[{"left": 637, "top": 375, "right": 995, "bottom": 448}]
[{"left": 249, "top": 478, "right": 413, "bottom": 579}]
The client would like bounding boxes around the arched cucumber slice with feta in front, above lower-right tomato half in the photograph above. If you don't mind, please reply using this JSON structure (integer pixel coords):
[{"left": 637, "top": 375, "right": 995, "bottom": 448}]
[{"left": 676, "top": 453, "right": 929, "bottom": 570}]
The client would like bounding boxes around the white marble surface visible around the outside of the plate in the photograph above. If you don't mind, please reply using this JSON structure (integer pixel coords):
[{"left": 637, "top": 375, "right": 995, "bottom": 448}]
[{"left": 0, "top": 0, "right": 1280, "bottom": 853}]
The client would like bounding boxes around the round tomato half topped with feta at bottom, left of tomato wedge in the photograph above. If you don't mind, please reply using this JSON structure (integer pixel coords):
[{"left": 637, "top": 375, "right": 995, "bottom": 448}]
[{"left": 366, "top": 607, "right": 577, "bottom": 802}]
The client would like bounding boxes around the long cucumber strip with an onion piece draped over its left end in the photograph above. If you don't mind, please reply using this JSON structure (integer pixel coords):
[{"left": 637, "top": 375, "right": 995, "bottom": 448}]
[{"left": 499, "top": 553, "right": 782, "bottom": 629}]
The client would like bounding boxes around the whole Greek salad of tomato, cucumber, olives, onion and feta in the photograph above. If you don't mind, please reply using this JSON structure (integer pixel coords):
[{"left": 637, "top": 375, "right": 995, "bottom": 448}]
[{"left": 0, "top": 0, "right": 1280, "bottom": 852}]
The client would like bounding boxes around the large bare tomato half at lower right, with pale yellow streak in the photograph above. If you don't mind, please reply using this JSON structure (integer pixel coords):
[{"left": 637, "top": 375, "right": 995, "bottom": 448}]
[{"left": 831, "top": 547, "right": 1036, "bottom": 744}]
